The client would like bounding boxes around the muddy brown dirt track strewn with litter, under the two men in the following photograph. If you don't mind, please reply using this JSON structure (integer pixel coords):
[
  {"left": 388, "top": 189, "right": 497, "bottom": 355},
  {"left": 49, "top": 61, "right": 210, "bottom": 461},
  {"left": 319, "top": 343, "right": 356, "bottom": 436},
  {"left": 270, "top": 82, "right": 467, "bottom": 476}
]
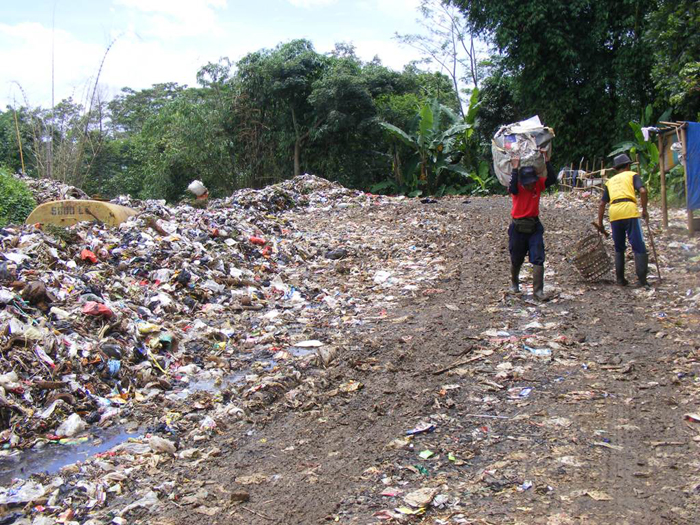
[{"left": 123, "top": 193, "right": 700, "bottom": 525}]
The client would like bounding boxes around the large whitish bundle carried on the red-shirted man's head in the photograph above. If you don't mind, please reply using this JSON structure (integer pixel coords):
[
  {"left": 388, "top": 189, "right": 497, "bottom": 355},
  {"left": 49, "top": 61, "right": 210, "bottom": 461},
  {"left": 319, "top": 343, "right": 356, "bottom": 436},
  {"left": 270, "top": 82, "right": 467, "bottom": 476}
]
[{"left": 491, "top": 115, "right": 554, "bottom": 186}]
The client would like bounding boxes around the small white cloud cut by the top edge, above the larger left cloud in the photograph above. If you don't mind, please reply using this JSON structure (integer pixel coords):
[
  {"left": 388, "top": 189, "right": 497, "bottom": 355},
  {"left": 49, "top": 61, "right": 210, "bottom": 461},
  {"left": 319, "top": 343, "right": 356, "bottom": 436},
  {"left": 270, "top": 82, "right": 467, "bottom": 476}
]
[{"left": 115, "top": 0, "right": 227, "bottom": 39}]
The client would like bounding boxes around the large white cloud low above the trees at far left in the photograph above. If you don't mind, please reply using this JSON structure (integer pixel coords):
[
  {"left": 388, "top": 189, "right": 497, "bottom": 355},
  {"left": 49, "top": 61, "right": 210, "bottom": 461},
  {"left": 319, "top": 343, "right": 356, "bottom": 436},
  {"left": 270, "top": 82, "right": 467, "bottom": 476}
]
[{"left": 0, "top": 23, "right": 208, "bottom": 109}]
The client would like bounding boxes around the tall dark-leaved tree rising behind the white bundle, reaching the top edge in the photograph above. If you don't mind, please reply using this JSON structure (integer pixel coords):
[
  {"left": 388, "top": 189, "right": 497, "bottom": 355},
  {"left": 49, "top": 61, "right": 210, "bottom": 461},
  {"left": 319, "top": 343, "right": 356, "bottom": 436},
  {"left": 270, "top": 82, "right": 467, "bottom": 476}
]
[{"left": 450, "top": 0, "right": 655, "bottom": 161}]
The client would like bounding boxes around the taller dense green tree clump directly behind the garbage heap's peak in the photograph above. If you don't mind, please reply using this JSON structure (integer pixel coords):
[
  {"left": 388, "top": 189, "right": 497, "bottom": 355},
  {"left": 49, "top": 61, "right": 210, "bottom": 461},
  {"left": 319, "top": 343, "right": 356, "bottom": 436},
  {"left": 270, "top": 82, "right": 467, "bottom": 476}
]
[{"left": 231, "top": 41, "right": 446, "bottom": 187}]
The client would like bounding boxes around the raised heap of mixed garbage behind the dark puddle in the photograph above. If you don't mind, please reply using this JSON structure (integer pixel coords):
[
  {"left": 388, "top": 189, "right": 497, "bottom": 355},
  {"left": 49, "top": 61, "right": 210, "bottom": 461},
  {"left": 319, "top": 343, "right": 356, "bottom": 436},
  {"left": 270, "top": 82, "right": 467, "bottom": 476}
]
[{"left": 0, "top": 176, "right": 369, "bottom": 448}]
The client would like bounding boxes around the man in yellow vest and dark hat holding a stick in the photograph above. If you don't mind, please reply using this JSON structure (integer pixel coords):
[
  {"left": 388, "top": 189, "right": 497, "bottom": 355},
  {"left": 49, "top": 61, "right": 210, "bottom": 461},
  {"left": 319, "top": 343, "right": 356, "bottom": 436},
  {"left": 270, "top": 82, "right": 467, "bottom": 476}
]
[{"left": 598, "top": 153, "right": 649, "bottom": 286}]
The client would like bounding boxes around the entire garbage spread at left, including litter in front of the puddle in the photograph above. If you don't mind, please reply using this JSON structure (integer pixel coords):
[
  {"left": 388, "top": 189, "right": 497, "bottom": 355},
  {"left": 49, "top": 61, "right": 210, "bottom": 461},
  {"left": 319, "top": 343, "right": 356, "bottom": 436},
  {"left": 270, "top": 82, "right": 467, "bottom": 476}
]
[{"left": 0, "top": 175, "right": 456, "bottom": 523}]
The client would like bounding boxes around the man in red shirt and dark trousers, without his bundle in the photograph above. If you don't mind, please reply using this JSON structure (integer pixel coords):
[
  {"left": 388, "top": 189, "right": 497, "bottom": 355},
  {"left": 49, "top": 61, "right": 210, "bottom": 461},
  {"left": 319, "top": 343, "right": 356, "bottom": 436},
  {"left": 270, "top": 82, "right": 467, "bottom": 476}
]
[{"left": 508, "top": 154, "right": 557, "bottom": 300}]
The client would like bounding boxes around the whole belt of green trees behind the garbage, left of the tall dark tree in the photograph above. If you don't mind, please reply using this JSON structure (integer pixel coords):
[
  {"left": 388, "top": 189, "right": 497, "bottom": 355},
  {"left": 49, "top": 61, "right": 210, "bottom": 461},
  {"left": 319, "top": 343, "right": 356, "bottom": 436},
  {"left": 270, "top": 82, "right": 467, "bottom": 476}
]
[{"left": 5, "top": 40, "right": 468, "bottom": 200}]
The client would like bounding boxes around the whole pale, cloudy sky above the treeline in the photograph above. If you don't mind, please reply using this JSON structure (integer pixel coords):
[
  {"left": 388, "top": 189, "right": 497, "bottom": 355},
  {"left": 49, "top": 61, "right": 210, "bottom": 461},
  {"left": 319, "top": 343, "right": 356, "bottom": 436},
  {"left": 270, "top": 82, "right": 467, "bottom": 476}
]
[{"left": 0, "top": 0, "right": 421, "bottom": 110}]
